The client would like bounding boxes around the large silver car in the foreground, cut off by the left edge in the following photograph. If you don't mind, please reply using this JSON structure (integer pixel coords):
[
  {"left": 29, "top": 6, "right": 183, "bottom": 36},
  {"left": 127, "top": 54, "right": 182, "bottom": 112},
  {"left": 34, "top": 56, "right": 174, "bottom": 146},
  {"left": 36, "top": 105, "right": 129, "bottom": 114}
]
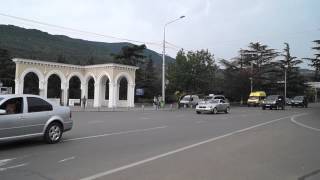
[{"left": 0, "top": 95, "right": 73, "bottom": 144}]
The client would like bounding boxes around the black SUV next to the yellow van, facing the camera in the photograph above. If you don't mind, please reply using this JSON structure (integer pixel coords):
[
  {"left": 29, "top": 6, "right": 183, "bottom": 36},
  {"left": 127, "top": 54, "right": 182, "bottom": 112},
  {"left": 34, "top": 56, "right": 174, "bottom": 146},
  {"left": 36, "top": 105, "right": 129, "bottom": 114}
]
[{"left": 262, "top": 95, "right": 286, "bottom": 110}]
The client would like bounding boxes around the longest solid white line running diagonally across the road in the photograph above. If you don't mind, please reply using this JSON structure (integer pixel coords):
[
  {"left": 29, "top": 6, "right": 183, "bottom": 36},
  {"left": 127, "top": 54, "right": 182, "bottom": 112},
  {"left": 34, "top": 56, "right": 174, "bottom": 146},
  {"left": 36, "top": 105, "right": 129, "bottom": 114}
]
[{"left": 81, "top": 114, "right": 300, "bottom": 180}]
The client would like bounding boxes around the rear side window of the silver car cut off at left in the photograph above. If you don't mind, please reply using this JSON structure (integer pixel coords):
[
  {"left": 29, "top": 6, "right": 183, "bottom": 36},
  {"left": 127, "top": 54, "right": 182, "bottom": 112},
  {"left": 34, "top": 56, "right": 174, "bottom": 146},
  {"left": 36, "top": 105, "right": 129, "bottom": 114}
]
[{"left": 27, "top": 97, "right": 53, "bottom": 113}]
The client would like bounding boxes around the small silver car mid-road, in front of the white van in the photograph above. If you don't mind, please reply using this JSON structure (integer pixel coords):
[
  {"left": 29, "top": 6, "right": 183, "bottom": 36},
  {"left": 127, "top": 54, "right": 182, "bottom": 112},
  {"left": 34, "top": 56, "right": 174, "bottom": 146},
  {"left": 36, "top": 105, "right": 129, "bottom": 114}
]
[{"left": 196, "top": 99, "right": 230, "bottom": 114}]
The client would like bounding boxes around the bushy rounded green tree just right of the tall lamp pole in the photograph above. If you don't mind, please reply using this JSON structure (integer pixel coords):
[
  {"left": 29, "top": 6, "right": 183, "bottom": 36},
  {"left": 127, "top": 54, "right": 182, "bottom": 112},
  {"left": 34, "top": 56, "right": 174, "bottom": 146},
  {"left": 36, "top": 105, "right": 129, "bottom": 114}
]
[{"left": 167, "top": 50, "right": 217, "bottom": 94}]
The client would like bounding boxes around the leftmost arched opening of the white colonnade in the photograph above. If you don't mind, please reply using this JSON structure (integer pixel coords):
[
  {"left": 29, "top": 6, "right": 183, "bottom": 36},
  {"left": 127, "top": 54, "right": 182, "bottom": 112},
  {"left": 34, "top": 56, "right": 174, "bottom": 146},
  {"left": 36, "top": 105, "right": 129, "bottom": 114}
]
[{"left": 23, "top": 72, "right": 40, "bottom": 95}]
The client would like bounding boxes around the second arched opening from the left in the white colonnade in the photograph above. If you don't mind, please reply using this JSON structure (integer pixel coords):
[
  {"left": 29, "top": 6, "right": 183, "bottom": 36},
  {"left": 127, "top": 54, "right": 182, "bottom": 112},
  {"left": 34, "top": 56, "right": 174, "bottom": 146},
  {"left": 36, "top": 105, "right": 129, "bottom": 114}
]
[{"left": 47, "top": 74, "right": 61, "bottom": 99}]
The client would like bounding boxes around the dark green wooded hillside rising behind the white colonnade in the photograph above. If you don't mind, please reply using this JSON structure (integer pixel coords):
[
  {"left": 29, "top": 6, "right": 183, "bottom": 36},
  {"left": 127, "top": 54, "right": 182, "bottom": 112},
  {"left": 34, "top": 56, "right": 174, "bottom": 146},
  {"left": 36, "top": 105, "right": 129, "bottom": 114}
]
[{"left": 0, "top": 25, "right": 174, "bottom": 65}]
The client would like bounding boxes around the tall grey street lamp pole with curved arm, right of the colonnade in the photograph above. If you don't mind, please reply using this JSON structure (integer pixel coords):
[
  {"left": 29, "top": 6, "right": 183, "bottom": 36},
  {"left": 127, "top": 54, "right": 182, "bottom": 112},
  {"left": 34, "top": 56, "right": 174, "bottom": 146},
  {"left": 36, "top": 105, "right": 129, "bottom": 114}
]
[{"left": 162, "top": 16, "right": 185, "bottom": 104}]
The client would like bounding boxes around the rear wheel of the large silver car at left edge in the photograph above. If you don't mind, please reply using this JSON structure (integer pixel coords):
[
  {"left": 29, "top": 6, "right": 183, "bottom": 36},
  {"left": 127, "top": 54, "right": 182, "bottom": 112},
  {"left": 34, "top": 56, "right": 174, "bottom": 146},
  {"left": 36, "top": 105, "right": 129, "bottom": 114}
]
[{"left": 44, "top": 122, "right": 63, "bottom": 144}]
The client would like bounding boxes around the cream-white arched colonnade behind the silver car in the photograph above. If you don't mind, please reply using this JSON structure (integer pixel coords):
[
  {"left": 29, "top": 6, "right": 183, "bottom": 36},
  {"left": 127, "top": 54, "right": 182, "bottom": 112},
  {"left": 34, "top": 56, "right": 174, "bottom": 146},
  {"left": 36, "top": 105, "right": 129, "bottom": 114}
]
[{"left": 13, "top": 58, "right": 138, "bottom": 108}]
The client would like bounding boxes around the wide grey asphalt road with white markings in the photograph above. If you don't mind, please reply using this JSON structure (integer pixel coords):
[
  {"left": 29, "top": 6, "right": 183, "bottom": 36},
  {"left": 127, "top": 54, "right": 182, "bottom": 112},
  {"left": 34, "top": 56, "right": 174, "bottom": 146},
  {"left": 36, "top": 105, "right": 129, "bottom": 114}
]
[{"left": 0, "top": 104, "right": 320, "bottom": 180}]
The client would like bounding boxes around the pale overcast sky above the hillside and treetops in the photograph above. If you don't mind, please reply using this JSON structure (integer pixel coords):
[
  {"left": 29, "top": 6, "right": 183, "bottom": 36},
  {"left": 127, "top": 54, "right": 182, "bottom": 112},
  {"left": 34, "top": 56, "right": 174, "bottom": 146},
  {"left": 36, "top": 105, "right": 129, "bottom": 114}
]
[{"left": 0, "top": 0, "right": 320, "bottom": 68}]
